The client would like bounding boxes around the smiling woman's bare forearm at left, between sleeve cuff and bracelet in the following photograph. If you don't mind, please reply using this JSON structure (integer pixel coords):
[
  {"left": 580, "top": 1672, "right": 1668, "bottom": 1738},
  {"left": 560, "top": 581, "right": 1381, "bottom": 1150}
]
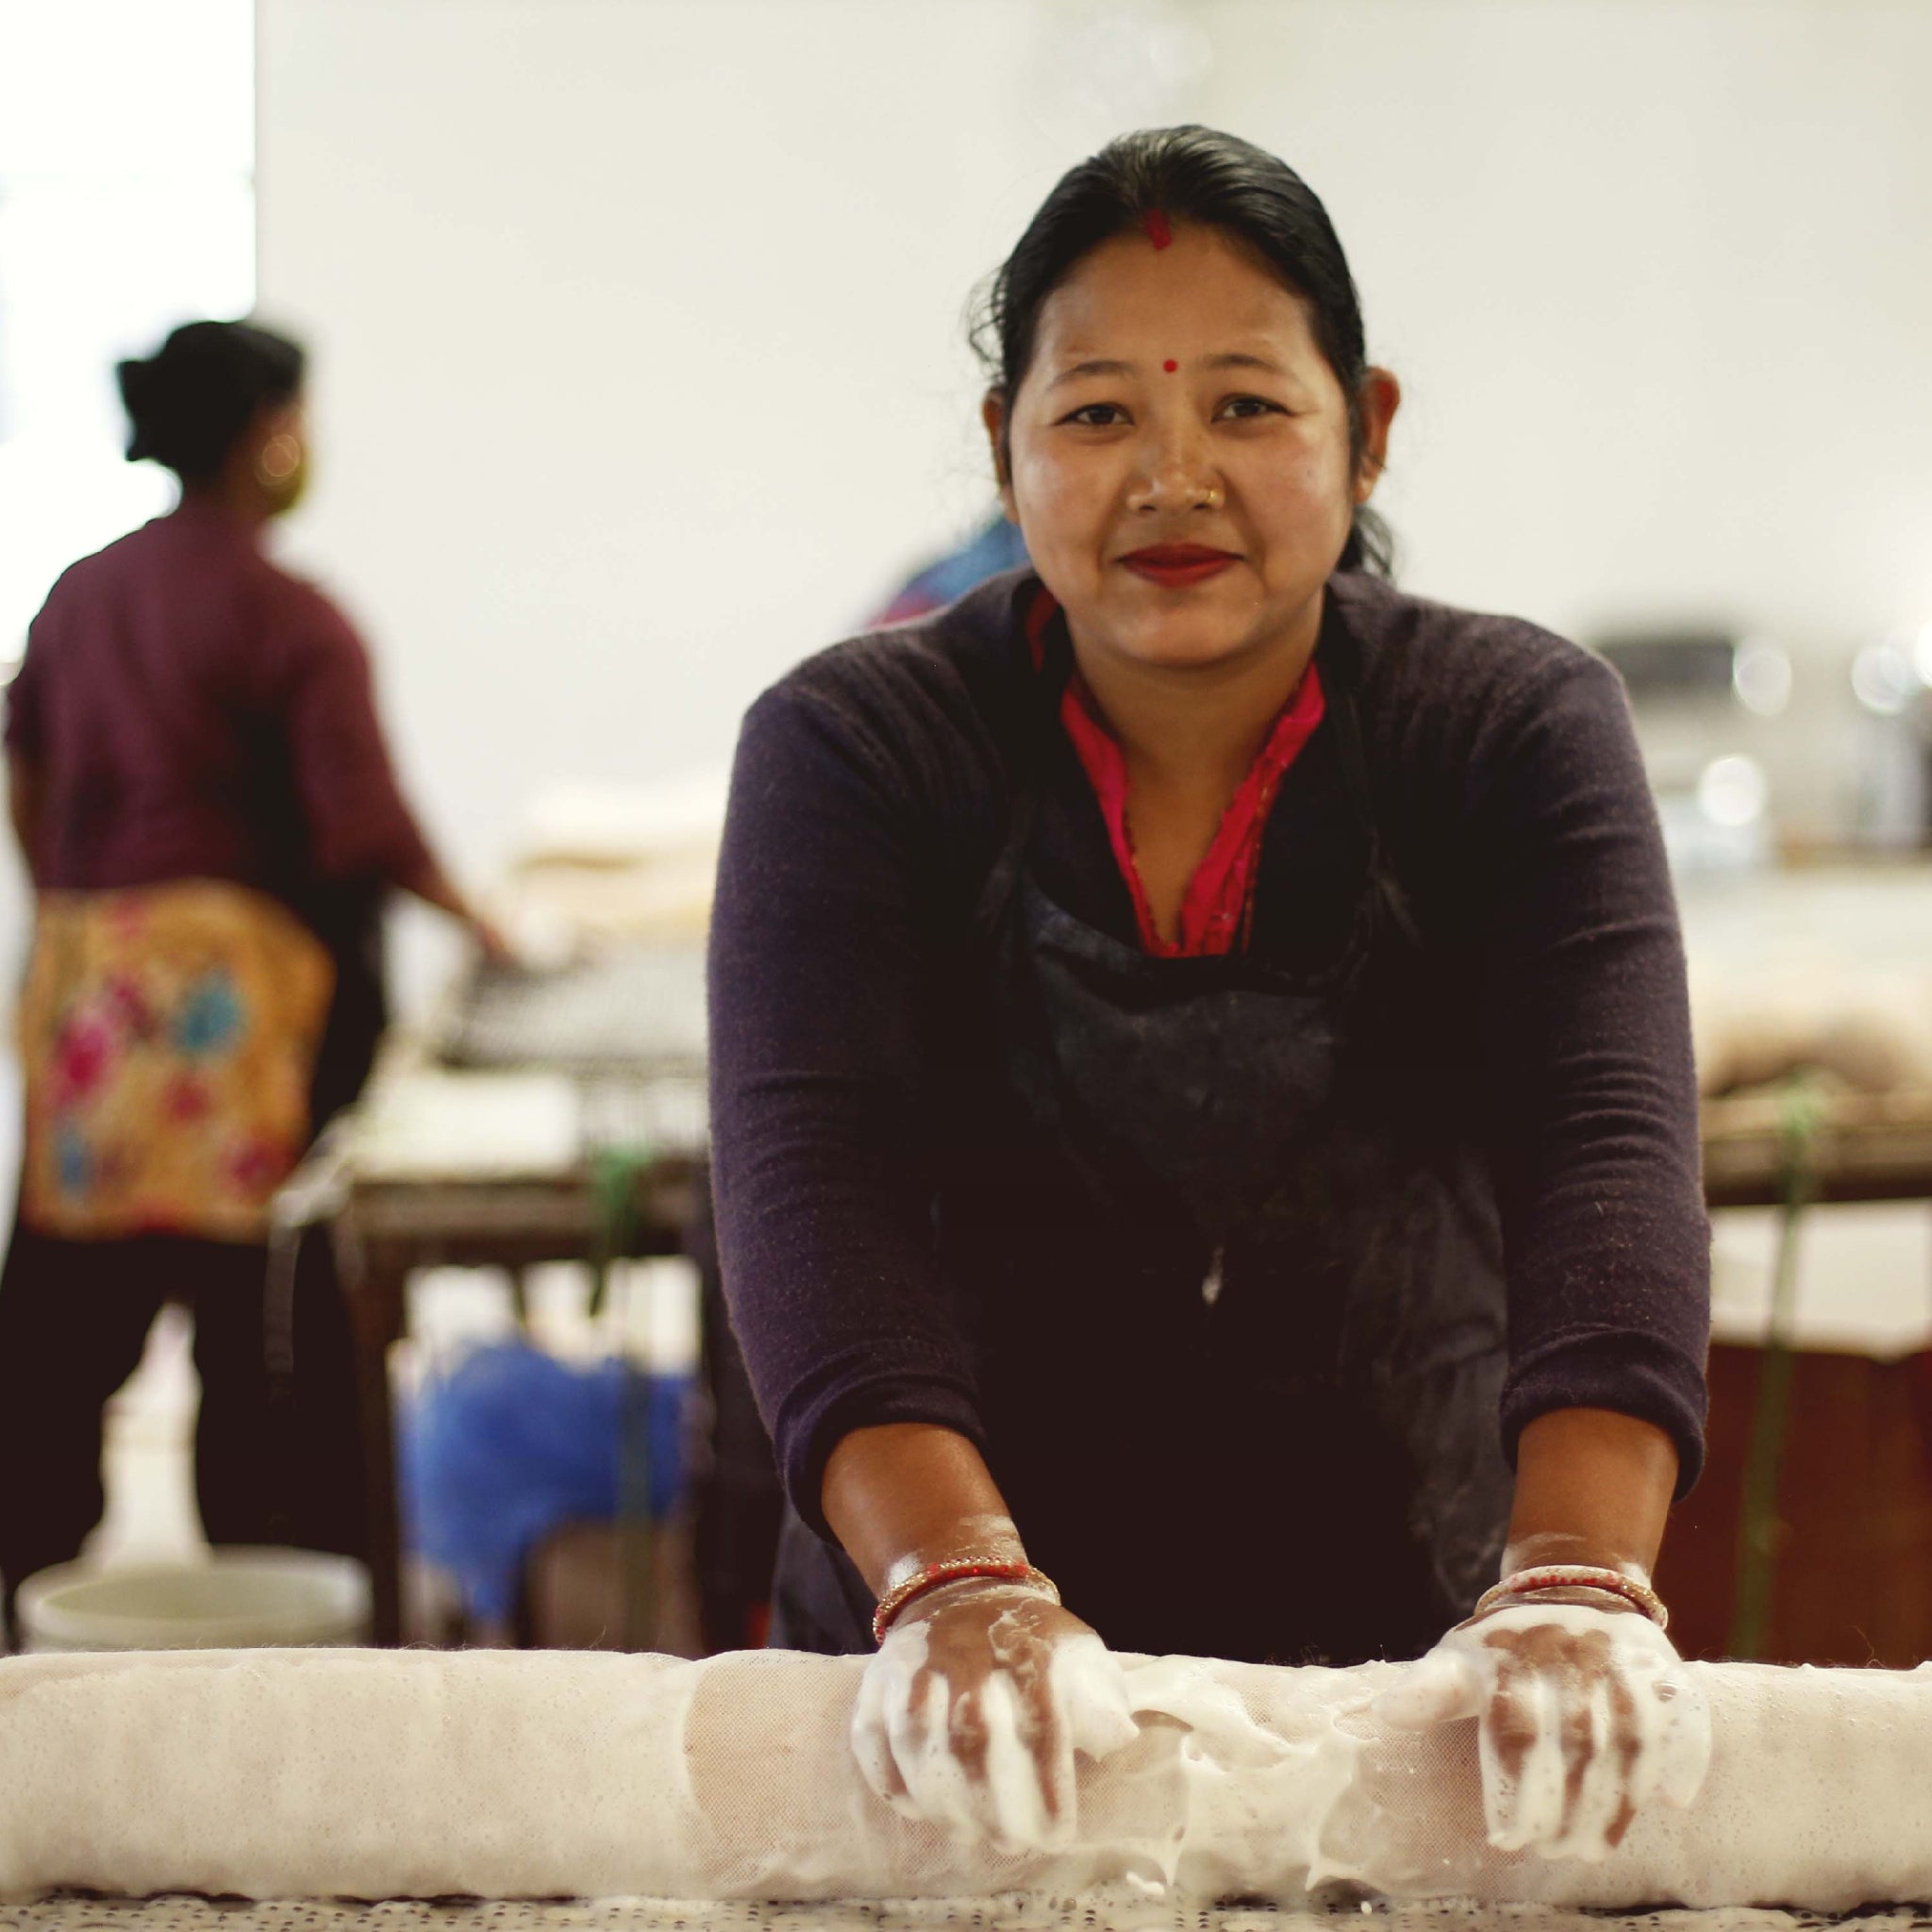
[{"left": 821, "top": 1422, "right": 1025, "bottom": 1596}]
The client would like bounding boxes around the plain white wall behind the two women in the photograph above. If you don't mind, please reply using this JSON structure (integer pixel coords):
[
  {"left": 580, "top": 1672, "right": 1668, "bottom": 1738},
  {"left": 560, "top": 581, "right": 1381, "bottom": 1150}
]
[{"left": 258, "top": 0, "right": 1932, "bottom": 889}]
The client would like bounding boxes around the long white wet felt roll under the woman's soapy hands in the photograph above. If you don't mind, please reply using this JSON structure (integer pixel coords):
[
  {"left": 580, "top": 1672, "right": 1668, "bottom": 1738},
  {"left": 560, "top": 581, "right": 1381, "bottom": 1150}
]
[{"left": 0, "top": 1650, "right": 1932, "bottom": 1910}]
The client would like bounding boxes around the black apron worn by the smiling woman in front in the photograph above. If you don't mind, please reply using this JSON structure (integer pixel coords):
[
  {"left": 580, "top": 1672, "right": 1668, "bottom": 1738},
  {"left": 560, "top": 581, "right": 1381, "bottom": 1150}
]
[{"left": 773, "top": 599, "right": 1511, "bottom": 1663}]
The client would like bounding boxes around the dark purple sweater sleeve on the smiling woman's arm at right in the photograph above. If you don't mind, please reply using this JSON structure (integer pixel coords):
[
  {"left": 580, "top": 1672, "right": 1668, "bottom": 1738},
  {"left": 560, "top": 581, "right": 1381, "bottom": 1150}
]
[{"left": 1468, "top": 647, "right": 1709, "bottom": 1493}]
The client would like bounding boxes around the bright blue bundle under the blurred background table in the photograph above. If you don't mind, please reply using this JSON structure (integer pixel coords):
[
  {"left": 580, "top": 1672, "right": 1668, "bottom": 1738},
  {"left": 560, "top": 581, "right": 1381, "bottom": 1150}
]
[{"left": 398, "top": 1341, "right": 691, "bottom": 1619}]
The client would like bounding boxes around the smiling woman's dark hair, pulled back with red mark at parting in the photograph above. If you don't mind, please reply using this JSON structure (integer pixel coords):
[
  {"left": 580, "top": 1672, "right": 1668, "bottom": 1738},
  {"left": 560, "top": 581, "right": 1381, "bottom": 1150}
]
[{"left": 972, "top": 127, "right": 1393, "bottom": 575}]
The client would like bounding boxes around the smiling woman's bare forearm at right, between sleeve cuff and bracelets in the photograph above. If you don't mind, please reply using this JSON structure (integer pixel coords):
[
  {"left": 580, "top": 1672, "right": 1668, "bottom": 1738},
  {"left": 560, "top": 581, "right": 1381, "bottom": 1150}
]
[{"left": 1503, "top": 1408, "right": 1677, "bottom": 1576}]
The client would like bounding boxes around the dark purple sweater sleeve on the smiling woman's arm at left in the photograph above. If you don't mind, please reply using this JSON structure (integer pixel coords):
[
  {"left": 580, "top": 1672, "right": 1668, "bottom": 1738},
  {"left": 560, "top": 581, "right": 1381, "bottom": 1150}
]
[{"left": 711, "top": 684, "right": 981, "bottom": 1534}]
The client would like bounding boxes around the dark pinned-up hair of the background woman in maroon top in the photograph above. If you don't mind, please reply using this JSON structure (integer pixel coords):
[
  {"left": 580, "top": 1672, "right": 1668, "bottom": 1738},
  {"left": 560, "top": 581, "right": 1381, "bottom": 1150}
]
[{"left": 114, "top": 323, "right": 308, "bottom": 483}]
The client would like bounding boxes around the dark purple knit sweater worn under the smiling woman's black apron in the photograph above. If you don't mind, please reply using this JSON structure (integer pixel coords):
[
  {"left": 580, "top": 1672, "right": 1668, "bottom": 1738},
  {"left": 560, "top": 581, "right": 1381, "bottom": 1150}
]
[{"left": 711, "top": 574, "right": 1707, "bottom": 1528}]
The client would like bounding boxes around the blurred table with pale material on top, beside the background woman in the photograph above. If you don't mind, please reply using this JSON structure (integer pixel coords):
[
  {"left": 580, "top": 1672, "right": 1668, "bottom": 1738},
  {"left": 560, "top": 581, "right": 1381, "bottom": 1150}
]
[{"left": 278, "top": 944, "right": 708, "bottom": 1644}]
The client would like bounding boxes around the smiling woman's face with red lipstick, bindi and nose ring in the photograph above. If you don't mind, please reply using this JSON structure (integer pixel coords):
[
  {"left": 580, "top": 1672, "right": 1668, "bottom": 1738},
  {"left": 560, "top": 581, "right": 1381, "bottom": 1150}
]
[{"left": 988, "top": 226, "right": 1401, "bottom": 669}]
